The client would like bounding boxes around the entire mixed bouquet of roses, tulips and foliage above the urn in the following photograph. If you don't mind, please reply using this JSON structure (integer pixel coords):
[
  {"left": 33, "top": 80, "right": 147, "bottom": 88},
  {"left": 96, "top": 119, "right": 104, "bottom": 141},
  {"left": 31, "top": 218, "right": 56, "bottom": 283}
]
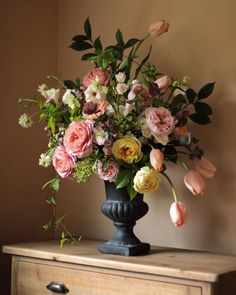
[{"left": 19, "top": 18, "right": 216, "bottom": 240}]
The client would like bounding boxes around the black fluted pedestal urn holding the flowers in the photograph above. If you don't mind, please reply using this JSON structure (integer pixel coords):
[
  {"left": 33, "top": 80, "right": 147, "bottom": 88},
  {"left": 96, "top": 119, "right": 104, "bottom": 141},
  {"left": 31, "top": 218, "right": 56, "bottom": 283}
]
[{"left": 99, "top": 181, "right": 150, "bottom": 256}]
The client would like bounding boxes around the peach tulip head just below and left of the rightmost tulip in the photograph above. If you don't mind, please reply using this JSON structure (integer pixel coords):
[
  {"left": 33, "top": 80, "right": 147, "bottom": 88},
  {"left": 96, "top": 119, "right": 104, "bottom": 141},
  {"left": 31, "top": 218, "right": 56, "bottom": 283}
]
[{"left": 184, "top": 170, "right": 206, "bottom": 196}]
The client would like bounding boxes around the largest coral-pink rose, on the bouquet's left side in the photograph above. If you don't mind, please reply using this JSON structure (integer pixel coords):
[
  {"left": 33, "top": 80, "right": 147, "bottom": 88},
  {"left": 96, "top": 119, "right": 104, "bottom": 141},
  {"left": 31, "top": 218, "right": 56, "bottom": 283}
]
[{"left": 63, "top": 120, "right": 93, "bottom": 158}]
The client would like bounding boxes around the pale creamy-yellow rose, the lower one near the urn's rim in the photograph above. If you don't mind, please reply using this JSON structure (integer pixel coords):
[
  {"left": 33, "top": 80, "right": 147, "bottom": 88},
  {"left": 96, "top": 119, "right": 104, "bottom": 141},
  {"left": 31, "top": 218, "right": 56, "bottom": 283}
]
[{"left": 134, "top": 166, "right": 160, "bottom": 194}]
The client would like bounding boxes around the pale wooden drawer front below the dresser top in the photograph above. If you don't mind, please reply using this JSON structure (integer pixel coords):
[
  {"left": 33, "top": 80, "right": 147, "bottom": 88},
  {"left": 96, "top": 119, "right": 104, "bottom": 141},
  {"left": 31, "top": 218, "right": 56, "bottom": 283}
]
[{"left": 13, "top": 260, "right": 202, "bottom": 295}]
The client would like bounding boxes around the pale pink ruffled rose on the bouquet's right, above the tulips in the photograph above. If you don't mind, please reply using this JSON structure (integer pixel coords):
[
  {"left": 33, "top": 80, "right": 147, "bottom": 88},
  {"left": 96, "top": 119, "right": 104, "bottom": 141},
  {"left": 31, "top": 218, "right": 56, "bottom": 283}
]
[{"left": 145, "top": 107, "right": 175, "bottom": 145}]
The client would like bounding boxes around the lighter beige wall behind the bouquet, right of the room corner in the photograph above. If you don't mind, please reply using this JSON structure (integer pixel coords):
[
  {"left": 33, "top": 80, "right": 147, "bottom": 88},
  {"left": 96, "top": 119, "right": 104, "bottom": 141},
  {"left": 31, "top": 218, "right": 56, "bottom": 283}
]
[{"left": 58, "top": 0, "right": 236, "bottom": 254}]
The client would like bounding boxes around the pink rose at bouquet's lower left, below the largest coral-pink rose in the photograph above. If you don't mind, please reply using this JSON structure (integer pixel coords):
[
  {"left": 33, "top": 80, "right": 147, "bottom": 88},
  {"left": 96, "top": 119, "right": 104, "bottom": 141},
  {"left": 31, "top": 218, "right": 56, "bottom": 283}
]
[{"left": 52, "top": 145, "right": 74, "bottom": 178}]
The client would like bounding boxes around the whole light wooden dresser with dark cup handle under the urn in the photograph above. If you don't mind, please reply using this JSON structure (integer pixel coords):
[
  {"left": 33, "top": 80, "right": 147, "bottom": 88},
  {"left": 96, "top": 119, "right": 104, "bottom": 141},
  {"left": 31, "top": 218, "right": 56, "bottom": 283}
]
[{"left": 3, "top": 240, "right": 236, "bottom": 295}]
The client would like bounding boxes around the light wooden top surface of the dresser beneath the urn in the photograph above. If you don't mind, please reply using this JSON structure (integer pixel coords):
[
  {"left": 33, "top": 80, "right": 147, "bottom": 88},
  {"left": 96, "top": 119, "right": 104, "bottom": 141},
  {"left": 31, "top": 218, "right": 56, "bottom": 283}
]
[{"left": 3, "top": 240, "right": 236, "bottom": 282}]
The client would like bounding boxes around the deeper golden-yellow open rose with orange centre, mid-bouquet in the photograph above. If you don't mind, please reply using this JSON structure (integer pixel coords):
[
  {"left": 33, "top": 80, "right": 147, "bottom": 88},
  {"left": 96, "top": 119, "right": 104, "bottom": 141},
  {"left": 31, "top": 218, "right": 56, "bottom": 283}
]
[{"left": 112, "top": 135, "right": 143, "bottom": 164}]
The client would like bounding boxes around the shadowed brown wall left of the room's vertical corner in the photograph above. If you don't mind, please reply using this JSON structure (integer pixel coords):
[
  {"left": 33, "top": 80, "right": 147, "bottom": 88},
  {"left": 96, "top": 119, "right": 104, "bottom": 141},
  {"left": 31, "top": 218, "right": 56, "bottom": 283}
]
[{"left": 0, "top": 0, "right": 58, "bottom": 295}]
